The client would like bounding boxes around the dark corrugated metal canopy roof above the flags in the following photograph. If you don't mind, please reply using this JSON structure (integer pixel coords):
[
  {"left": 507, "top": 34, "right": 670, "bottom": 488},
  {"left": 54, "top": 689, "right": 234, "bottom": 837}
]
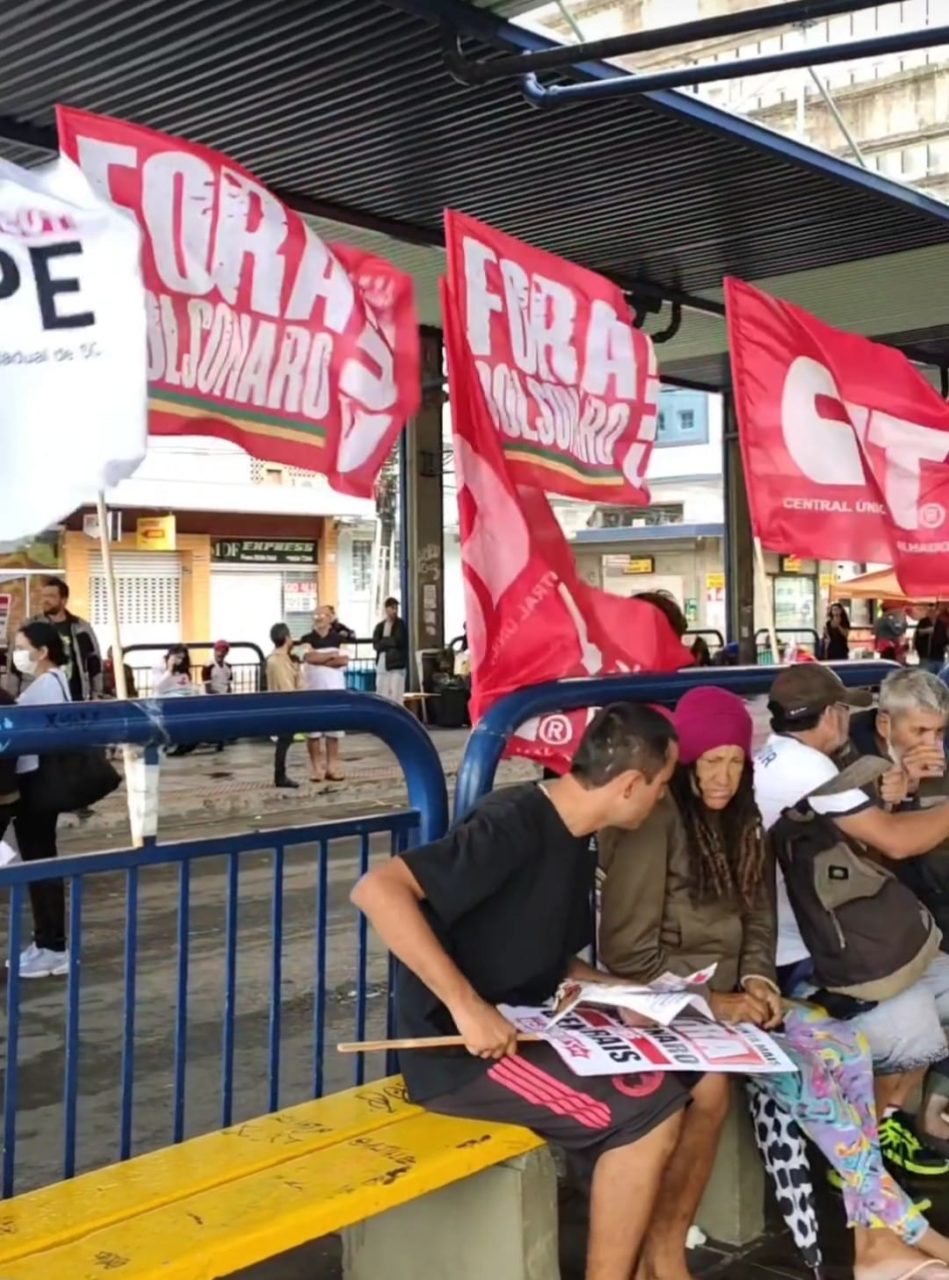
[{"left": 0, "top": 0, "right": 949, "bottom": 385}]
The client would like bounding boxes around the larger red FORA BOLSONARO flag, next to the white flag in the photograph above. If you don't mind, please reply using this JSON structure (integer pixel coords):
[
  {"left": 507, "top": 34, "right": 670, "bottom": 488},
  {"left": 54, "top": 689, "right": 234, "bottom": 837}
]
[{"left": 56, "top": 108, "right": 421, "bottom": 498}]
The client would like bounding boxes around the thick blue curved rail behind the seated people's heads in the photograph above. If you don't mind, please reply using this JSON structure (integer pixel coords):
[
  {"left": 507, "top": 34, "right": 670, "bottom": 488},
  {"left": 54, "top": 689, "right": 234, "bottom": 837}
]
[{"left": 455, "top": 662, "right": 895, "bottom": 820}]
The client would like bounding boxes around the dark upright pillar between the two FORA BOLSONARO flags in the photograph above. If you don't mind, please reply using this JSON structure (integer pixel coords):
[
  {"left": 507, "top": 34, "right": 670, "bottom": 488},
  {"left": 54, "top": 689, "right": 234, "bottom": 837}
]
[{"left": 402, "top": 329, "right": 446, "bottom": 687}]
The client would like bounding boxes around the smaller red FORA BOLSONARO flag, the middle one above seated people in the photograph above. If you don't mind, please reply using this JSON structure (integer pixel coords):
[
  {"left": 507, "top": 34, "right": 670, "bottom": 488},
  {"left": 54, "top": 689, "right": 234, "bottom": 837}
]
[{"left": 444, "top": 211, "right": 650, "bottom": 506}]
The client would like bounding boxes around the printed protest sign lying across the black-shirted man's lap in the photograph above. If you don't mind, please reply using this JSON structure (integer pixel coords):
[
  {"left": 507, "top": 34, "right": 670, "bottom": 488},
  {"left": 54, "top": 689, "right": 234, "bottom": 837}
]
[{"left": 499, "top": 1005, "right": 797, "bottom": 1075}]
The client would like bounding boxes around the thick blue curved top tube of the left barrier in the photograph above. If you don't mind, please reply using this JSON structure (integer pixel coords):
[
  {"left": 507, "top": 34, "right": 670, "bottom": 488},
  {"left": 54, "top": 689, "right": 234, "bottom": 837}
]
[{"left": 0, "top": 690, "right": 448, "bottom": 840}]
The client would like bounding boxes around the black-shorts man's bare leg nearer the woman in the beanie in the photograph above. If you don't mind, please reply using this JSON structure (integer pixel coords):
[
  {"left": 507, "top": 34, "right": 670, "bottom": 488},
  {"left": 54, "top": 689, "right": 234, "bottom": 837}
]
[{"left": 639, "top": 1075, "right": 731, "bottom": 1280}]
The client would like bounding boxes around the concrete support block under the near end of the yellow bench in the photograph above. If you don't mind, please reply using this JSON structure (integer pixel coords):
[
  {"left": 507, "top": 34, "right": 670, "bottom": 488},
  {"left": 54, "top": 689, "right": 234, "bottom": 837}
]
[{"left": 342, "top": 1147, "right": 560, "bottom": 1280}]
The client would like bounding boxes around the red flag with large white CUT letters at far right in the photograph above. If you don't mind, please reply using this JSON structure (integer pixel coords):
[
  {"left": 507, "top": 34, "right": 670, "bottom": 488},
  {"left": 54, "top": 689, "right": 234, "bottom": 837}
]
[{"left": 725, "top": 279, "right": 949, "bottom": 598}]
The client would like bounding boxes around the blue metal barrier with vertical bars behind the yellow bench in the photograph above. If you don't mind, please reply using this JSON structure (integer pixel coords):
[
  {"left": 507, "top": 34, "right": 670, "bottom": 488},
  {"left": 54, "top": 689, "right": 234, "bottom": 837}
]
[{"left": 0, "top": 691, "right": 447, "bottom": 1197}]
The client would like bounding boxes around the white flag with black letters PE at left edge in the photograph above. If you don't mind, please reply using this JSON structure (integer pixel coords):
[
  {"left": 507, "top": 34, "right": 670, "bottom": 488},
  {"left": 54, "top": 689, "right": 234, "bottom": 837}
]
[{"left": 0, "top": 157, "right": 147, "bottom": 541}]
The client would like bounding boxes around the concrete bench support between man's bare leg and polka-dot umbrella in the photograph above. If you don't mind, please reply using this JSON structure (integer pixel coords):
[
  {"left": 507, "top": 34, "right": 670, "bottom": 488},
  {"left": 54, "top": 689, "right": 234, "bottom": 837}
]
[{"left": 697, "top": 1082, "right": 765, "bottom": 1245}]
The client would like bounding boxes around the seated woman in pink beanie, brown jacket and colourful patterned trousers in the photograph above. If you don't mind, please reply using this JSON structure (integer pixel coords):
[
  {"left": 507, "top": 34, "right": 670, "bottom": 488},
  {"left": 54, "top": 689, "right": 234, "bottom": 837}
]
[{"left": 599, "top": 685, "right": 949, "bottom": 1280}]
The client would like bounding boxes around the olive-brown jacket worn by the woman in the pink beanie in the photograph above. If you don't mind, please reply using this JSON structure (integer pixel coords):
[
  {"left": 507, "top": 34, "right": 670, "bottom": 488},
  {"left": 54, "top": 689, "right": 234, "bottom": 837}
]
[{"left": 598, "top": 797, "right": 776, "bottom": 992}]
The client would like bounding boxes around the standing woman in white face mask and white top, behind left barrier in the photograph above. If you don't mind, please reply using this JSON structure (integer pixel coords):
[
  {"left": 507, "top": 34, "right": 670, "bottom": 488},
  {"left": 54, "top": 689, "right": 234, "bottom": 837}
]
[{"left": 13, "top": 622, "right": 72, "bottom": 978}]
